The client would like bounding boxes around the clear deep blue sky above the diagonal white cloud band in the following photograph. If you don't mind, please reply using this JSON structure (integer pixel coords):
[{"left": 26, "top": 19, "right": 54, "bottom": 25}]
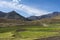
[{"left": 23, "top": 0, "right": 60, "bottom": 11}]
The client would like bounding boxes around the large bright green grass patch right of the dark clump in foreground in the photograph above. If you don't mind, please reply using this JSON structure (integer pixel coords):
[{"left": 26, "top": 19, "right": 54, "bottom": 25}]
[{"left": 18, "top": 31, "right": 59, "bottom": 38}]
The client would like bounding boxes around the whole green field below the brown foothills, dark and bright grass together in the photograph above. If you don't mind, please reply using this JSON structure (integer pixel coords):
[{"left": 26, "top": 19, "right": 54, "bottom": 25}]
[{"left": 0, "top": 24, "right": 60, "bottom": 40}]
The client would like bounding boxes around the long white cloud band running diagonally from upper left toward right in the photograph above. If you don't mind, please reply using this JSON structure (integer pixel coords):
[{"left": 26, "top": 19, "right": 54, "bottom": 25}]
[{"left": 0, "top": 0, "right": 49, "bottom": 16}]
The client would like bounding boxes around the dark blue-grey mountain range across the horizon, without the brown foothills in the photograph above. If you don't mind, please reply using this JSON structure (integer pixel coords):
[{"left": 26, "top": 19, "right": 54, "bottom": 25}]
[{"left": 0, "top": 11, "right": 60, "bottom": 21}]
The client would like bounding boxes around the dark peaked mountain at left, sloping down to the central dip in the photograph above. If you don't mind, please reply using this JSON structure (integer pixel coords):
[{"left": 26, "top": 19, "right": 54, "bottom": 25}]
[{"left": 0, "top": 11, "right": 28, "bottom": 20}]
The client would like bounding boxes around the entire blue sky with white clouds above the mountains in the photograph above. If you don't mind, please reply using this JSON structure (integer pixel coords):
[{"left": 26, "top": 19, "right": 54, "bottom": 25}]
[{"left": 0, "top": 0, "right": 60, "bottom": 17}]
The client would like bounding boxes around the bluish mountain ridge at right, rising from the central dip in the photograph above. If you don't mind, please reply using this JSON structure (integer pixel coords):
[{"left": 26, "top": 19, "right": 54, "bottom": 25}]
[{"left": 28, "top": 12, "right": 60, "bottom": 20}]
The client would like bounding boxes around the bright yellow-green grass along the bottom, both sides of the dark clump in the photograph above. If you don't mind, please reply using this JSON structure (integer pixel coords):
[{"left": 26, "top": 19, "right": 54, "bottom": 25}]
[{"left": 0, "top": 31, "right": 59, "bottom": 40}]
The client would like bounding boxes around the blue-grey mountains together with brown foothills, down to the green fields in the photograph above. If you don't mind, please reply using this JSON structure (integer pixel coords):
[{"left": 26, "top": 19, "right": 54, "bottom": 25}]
[{"left": 0, "top": 11, "right": 60, "bottom": 26}]
